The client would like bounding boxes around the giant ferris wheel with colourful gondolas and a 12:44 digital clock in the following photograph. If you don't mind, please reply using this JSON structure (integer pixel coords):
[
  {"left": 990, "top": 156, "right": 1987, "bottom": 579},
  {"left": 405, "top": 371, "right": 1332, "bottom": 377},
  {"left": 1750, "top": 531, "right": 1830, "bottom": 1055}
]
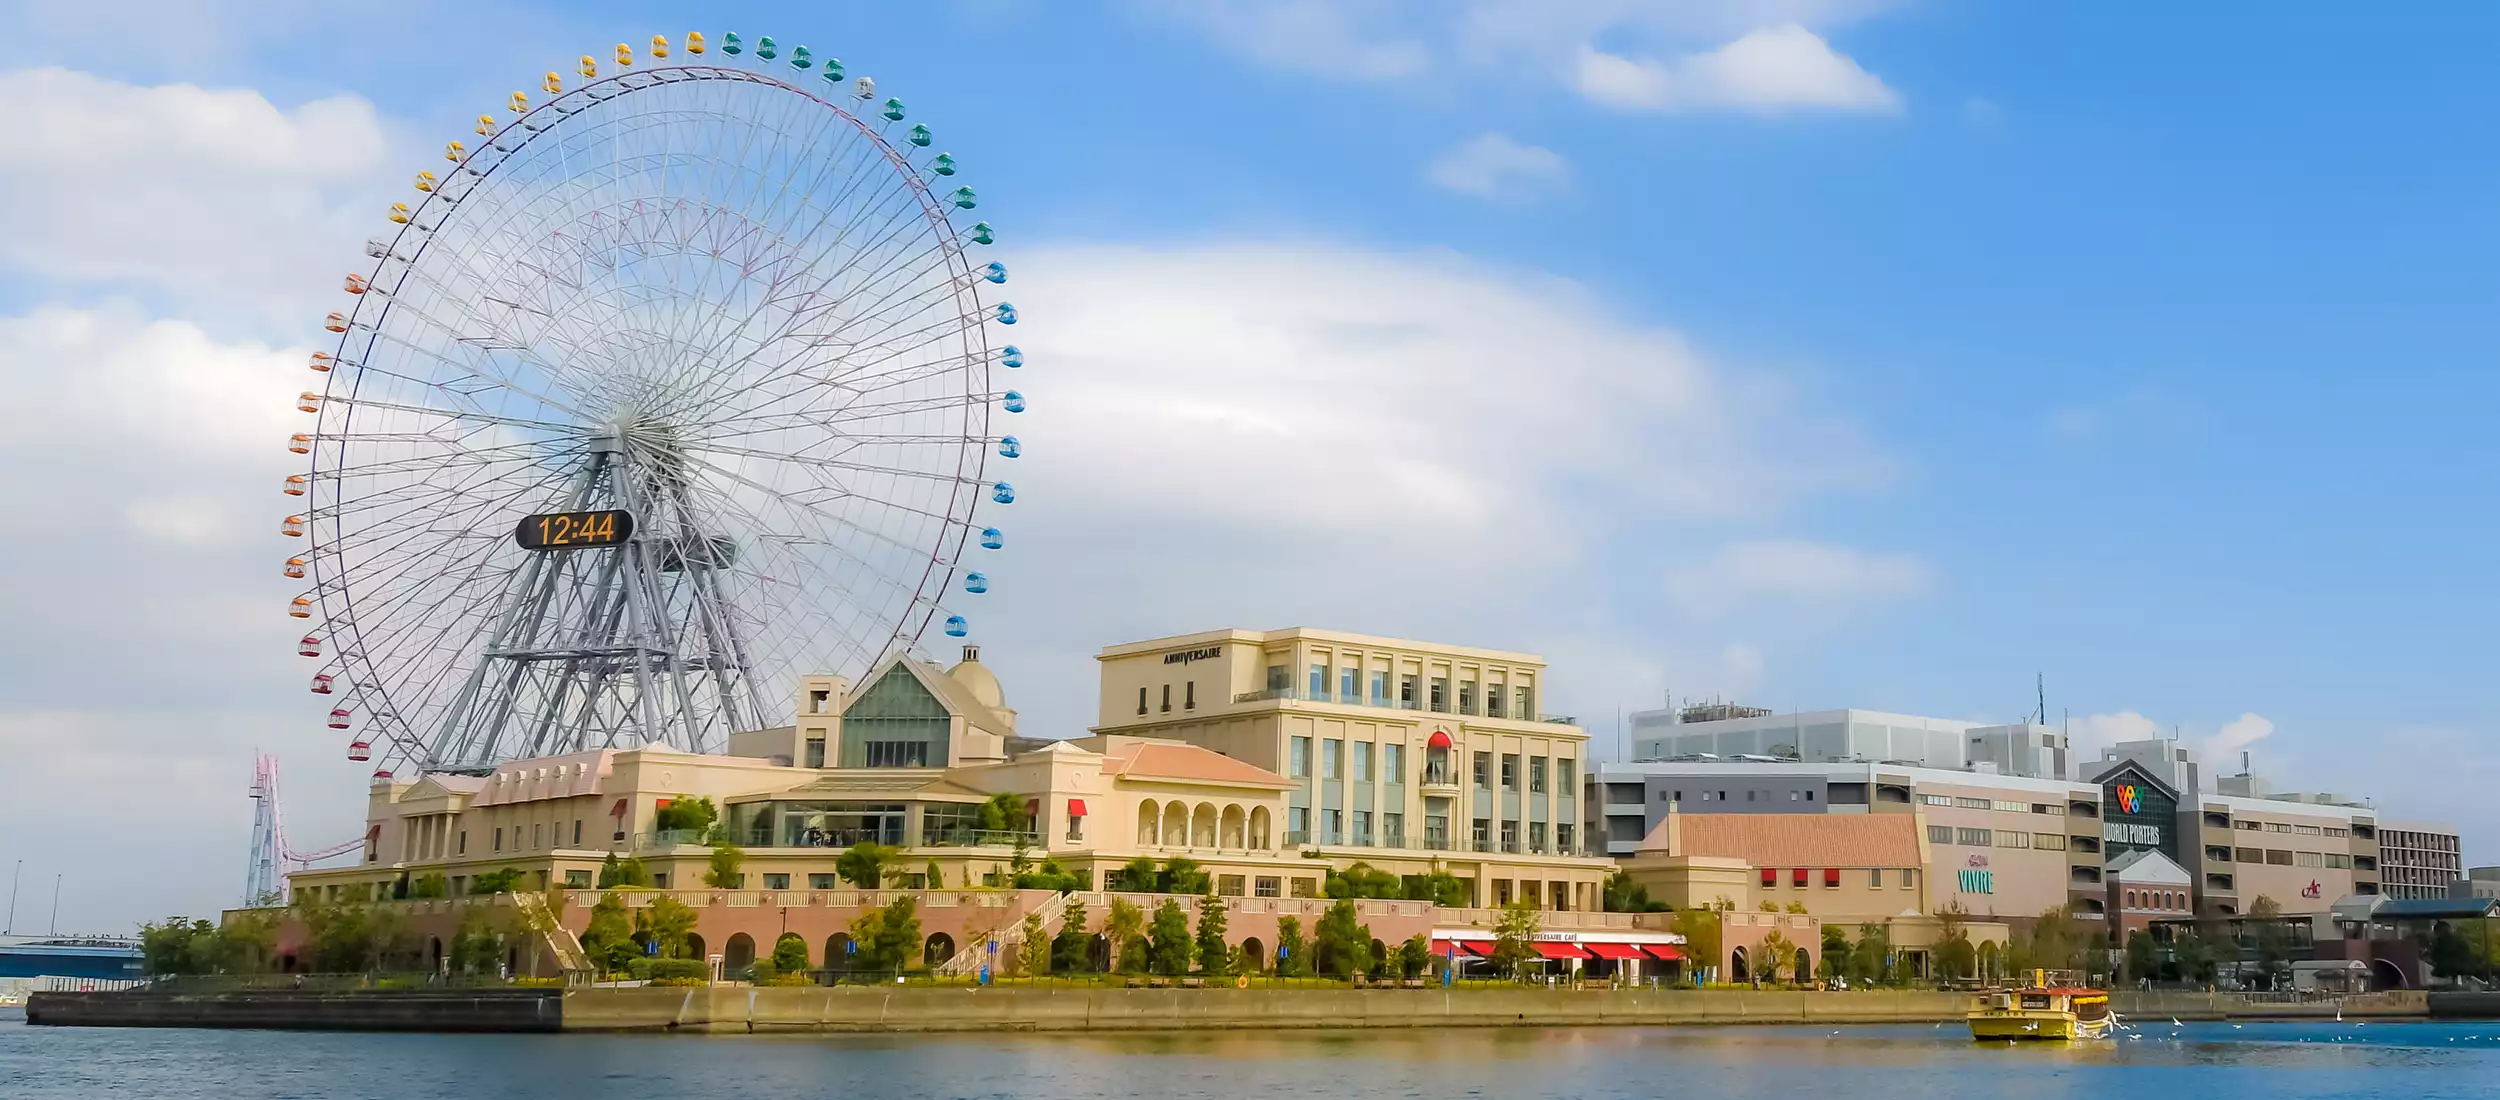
[{"left": 283, "top": 33, "right": 1025, "bottom": 778}]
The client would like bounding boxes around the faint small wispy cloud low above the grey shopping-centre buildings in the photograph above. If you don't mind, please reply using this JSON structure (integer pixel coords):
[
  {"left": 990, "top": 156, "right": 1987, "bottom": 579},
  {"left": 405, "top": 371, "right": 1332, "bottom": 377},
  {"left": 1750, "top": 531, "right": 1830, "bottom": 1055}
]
[{"left": 1668, "top": 538, "right": 1930, "bottom": 610}]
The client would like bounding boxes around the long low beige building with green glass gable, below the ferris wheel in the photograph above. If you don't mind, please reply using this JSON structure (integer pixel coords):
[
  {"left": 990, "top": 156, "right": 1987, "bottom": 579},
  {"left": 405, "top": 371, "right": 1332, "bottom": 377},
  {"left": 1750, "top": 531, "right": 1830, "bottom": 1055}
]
[{"left": 293, "top": 635, "right": 1605, "bottom": 910}]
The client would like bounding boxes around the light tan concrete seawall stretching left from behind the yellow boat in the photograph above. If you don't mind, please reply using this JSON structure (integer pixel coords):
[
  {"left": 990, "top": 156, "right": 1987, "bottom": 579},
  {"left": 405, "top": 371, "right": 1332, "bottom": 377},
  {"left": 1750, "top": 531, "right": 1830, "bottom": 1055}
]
[{"left": 565, "top": 988, "right": 1970, "bottom": 1033}]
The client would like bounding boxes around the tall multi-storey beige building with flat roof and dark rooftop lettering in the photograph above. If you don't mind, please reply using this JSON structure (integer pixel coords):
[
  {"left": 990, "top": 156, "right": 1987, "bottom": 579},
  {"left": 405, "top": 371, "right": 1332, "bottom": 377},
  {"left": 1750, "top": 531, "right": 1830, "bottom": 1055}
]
[{"left": 1095, "top": 628, "right": 1610, "bottom": 910}]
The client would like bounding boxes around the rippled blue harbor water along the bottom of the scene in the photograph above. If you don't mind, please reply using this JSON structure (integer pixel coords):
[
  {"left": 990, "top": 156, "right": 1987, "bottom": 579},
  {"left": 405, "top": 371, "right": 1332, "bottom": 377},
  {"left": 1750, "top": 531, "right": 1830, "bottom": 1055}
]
[{"left": 0, "top": 1010, "right": 2500, "bottom": 1100}]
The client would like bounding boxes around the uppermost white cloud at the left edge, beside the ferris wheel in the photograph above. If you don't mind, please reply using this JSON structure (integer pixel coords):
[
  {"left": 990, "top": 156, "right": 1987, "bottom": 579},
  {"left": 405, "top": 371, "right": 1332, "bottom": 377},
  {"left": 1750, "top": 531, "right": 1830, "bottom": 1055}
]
[{"left": 0, "top": 68, "right": 392, "bottom": 328}]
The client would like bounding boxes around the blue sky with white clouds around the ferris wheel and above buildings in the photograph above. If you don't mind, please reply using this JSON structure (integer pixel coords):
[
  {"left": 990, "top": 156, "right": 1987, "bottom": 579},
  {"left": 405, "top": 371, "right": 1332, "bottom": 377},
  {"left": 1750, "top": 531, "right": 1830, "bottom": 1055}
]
[{"left": 0, "top": 0, "right": 2500, "bottom": 925}]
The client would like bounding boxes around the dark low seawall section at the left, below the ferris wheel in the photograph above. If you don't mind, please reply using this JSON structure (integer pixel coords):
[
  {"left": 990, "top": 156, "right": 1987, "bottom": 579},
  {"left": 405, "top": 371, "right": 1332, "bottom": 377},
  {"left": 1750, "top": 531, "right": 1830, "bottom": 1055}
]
[{"left": 25, "top": 990, "right": 565, "bottom": 1033}]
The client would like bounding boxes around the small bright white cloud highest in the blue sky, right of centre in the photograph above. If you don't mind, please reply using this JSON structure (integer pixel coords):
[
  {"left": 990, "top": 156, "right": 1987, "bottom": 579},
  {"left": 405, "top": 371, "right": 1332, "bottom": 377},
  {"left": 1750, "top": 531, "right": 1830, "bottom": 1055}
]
[{"left": 1578, "top": 25, "right": 1900, "bottom": 113}]
